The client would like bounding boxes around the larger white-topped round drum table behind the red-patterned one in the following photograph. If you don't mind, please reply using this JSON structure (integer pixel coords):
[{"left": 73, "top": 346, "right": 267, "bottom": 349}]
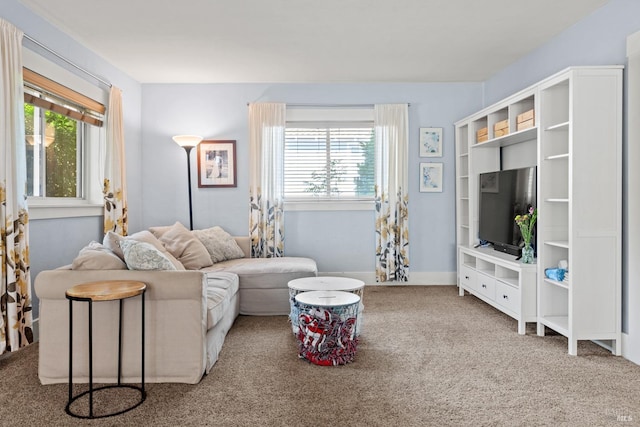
[{"left": 288, "top": 276, "right": 364, "bottom": 336}]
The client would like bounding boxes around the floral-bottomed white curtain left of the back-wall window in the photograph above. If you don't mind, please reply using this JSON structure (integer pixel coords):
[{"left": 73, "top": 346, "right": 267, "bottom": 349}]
[{"left": 249, "top": 103, "right": 286, "bottom": 258}]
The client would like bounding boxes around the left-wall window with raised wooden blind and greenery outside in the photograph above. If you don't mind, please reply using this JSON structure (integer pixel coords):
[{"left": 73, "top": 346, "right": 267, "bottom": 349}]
[{"left": 23, "top": 49, "right": 105, "bottom": 219}]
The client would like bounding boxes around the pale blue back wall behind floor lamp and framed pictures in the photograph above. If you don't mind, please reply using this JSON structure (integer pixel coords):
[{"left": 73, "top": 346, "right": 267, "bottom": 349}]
[{"left": 142, "top": 83, "right": 482, "bottom": 273}]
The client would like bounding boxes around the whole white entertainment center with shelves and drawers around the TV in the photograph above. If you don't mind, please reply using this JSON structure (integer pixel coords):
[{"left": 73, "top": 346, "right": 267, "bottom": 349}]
[{"left": 455, "top": 66, "right": 623, "bottom": 355}]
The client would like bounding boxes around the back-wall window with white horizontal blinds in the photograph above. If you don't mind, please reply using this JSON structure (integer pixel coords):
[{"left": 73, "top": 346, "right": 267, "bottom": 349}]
[{"left": 284, "top": 109, "right": 375, "bottom": 206}]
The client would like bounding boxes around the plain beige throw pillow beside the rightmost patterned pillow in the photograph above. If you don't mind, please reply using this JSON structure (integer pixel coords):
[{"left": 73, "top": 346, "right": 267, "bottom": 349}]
[{"left": 149, "top": 222, "right": 213, "bottom": 270}]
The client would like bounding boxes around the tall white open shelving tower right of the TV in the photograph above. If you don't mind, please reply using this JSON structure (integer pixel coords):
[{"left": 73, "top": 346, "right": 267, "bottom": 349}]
[{"left": 538, "top": 67, "right": 622, "bottom": 355}]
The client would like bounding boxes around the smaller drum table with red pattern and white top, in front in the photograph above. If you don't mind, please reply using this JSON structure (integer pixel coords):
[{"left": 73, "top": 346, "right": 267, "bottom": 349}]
[{"left": 295, "top": 291, "right": 360, "bottom": 366}]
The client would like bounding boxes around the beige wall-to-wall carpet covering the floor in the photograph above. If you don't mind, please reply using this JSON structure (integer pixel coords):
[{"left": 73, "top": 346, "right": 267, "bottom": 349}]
[{"left": 0, "top": 286, "right": 640, "bottom": 427}]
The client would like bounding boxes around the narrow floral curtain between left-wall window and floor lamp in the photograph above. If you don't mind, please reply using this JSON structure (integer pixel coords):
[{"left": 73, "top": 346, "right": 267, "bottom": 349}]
[{"left": 102, "top": 86, "right": 127, "bottom": 236}]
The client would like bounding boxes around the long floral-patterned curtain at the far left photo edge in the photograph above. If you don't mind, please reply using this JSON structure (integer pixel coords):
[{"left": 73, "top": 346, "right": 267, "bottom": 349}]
[{"left": 0, "top": 18, "right": 33, "bottom": 354}]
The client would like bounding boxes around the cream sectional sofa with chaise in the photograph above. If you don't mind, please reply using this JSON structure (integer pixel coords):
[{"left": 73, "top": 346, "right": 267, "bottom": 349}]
[{"left": 34, "top": 226, "right": 317, "bottom": 384}]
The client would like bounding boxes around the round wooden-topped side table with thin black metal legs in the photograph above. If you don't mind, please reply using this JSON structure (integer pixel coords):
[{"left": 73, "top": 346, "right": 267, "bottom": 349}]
[{"left": 65, "top": 280, "right": 147, "bottom": 418}]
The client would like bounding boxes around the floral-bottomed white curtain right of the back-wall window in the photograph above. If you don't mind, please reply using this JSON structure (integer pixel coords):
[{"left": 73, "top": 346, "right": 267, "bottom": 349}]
[{"left": 374, "top": 104, "right": 409, "bottom": 282}]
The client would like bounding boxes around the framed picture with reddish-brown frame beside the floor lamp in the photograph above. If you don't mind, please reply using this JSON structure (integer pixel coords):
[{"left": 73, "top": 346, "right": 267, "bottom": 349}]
[{"left": 198, "top": 141, "right": 237, "bottom": 187}]
